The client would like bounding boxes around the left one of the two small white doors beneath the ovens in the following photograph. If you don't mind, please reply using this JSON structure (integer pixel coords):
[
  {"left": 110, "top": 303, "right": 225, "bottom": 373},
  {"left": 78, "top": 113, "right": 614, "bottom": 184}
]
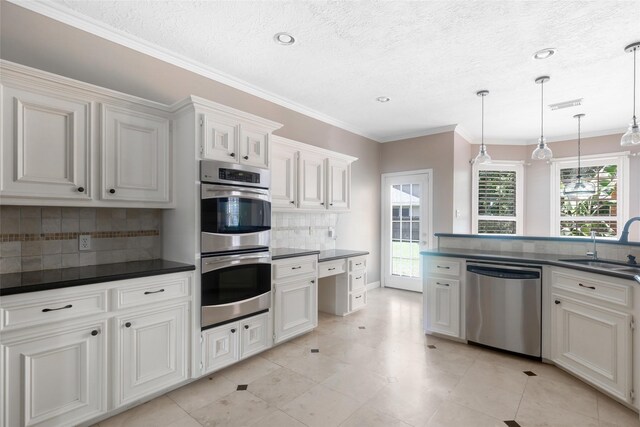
[{"left": 202, "top": 322, "right": 240, "bottom": 374}]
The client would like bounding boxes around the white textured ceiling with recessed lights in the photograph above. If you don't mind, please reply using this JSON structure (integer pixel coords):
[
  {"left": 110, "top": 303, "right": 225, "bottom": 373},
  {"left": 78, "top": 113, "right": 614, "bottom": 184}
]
[{"left": 17, "top": 0, "right": 640, "bottom": 143}]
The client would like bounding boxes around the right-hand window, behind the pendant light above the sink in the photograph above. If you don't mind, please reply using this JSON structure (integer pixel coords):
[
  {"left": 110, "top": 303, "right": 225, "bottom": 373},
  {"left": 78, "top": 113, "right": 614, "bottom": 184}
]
[{"left": 551, "top": 153, "right": 629, "bottom": 238}]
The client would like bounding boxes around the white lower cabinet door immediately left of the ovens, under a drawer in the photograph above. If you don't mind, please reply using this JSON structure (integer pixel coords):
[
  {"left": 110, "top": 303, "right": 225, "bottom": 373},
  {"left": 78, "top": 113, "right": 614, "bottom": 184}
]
[{"left": 114, "top": 303, "right": 189, "bottom": 406}]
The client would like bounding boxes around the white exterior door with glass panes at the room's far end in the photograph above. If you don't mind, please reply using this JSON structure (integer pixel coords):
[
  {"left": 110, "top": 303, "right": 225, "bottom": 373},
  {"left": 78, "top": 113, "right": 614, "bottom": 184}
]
[{"left": 382, "top": 172, "right": 431, "bottom": 292}]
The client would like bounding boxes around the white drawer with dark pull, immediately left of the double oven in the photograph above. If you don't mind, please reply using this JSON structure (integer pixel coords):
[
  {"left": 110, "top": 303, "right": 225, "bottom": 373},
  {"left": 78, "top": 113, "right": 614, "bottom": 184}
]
[{"left": 113, "top": 276, "right": 189, "bottom": 310}]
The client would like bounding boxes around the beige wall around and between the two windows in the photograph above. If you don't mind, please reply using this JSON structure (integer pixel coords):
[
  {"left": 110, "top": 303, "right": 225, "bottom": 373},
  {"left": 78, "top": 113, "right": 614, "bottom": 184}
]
[{"left": 471, "top": 134, "right": 640, "bottom": 241}]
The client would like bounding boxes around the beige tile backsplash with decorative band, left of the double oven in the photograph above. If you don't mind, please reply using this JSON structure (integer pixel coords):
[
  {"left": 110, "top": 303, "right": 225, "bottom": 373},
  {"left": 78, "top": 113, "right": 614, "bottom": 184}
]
[{"left": 0, "top": 206, "right": 162, "bottom": 273}]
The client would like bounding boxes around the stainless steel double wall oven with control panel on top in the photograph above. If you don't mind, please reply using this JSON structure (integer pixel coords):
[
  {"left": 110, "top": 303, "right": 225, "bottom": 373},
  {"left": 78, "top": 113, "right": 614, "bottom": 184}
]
[{"left": 200, "top": 160, "right": 271, "bottom": 329}]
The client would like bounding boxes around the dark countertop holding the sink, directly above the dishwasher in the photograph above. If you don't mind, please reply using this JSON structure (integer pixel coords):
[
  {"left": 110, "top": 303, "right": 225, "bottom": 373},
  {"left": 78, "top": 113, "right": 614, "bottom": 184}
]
[{"left": 420, "top": 248, "right": 640, "bottom": 283}]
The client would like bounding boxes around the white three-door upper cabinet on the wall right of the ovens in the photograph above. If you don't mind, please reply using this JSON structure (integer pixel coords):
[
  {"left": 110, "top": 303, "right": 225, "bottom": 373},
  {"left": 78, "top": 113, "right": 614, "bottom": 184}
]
[{"left": 271, "top": 135, "right": 358, "bottom": 211}]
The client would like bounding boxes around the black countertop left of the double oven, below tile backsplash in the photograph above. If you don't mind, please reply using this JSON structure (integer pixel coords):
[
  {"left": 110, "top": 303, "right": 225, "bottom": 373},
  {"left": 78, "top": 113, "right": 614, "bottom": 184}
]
[{"left": 0, "top": 259, "right": 196, "bottom": 296}]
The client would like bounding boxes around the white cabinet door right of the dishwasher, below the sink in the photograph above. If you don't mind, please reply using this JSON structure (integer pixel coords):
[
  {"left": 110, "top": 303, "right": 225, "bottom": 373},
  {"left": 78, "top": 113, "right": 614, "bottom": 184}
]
[{"left": 551, "top": 294, "right": 632, "bottom": 402}]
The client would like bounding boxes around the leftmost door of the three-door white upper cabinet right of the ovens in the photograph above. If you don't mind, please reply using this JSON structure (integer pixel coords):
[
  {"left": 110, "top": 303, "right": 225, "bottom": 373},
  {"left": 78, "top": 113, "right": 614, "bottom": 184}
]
[{"left": 271, "top": 142, "right": 298, "bottom": 209}]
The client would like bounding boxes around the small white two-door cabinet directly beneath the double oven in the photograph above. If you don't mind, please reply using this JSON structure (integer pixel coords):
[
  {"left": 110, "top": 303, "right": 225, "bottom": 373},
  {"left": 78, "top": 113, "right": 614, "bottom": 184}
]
[{"left": 202, "top": 312, "right": 271, "bottom": 374}]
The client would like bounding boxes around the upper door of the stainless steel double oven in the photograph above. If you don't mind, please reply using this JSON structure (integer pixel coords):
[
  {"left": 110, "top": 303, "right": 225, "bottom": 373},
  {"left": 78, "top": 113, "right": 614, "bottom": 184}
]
[{"left": 200, "top": 184, "right": 271, "bottom": 235}]
